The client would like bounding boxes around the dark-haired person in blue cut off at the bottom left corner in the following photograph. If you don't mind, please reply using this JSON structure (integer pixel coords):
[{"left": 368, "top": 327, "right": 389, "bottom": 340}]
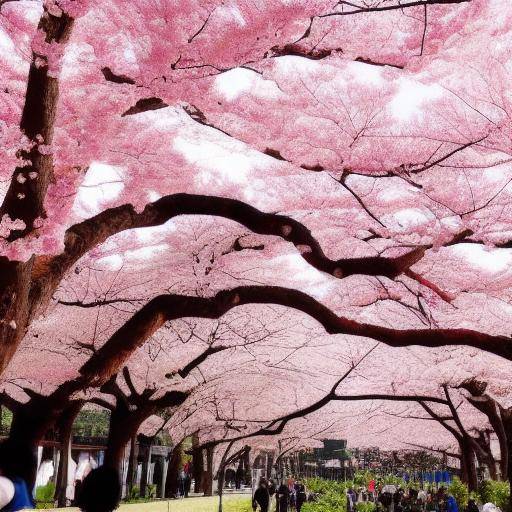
[{"left": 0, "top": 440, "right": 36, "bottom": 512}]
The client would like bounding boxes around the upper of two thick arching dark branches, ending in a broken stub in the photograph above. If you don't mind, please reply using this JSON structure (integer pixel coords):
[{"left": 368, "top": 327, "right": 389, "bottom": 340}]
[{"left": 48, "top": 194, "right": 426, "bottom": 288}]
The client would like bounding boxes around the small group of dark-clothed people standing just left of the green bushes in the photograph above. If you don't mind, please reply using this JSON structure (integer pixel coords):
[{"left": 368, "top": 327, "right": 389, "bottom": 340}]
[{"left": 252, "top": 478, "right": 308, "bottom": 512}]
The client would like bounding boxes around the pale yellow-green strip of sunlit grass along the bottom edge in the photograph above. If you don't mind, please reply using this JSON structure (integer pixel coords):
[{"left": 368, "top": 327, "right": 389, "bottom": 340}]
[{"left": 50, "top": 496, "right": 252, "bottom": 512}]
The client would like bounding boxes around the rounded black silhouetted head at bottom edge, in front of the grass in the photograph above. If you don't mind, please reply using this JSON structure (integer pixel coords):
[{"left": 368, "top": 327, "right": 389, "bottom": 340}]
[{"left": 76, "top": 466, "right": 121, "bottom": 512}]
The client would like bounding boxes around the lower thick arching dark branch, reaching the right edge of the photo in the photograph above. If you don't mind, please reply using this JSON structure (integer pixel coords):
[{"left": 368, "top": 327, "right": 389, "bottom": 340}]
[{"left": 76, "top": 286, "right": 512, "bottom": 385}]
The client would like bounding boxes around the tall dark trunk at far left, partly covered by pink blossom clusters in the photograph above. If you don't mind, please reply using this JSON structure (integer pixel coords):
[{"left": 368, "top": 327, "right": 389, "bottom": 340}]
[{"left": 0, "top": 9, "right": 73, "bottom": 375}]
